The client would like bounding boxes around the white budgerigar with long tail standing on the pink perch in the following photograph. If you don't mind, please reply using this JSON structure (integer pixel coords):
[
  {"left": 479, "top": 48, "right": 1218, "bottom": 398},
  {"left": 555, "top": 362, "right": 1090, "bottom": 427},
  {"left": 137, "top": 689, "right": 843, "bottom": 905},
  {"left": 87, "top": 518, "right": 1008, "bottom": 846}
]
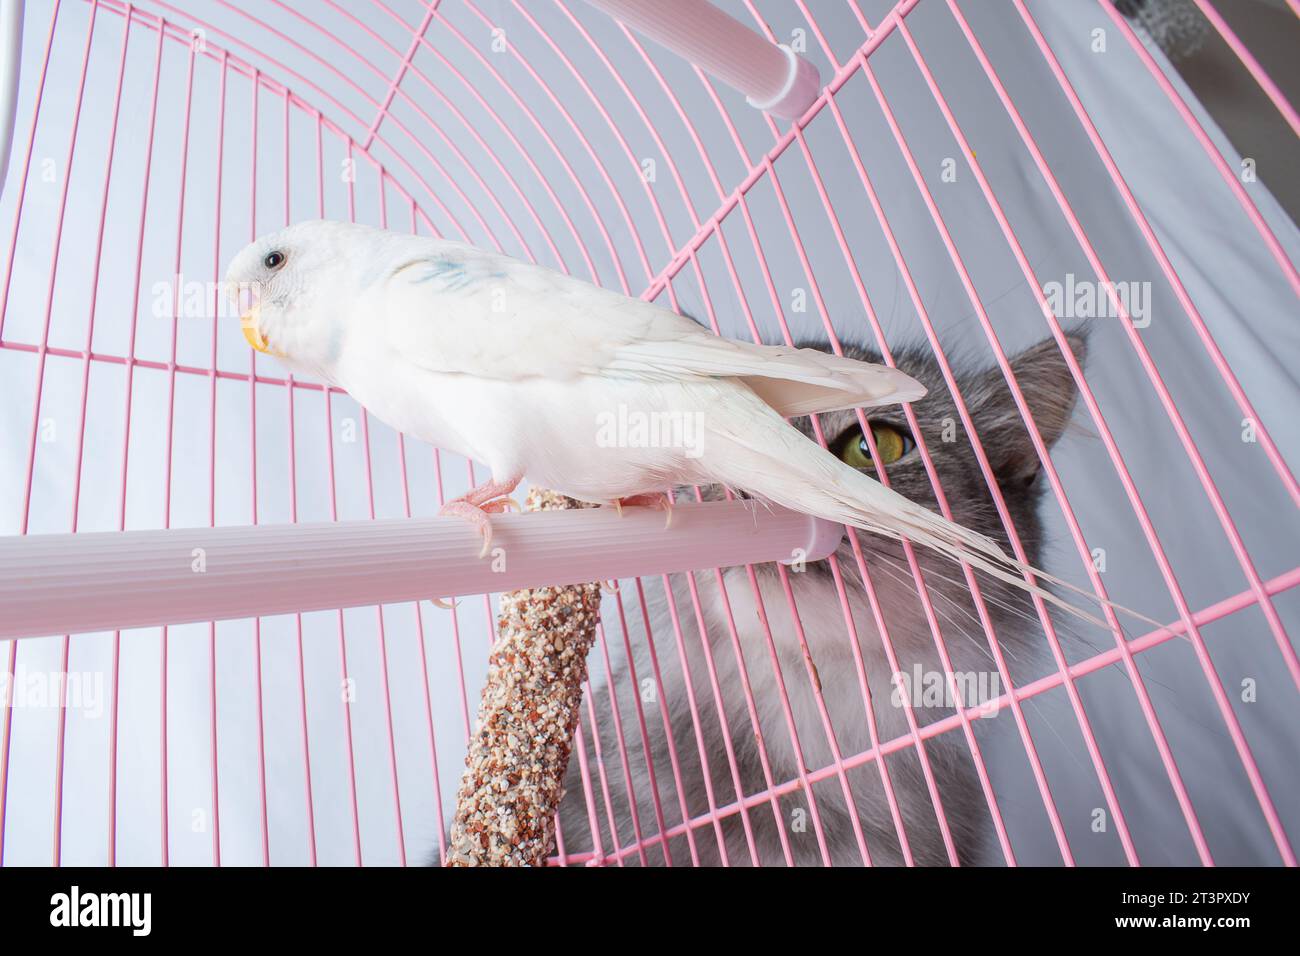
[{"left": 226, "top": 221, "right": 1138, "bottom": 632}]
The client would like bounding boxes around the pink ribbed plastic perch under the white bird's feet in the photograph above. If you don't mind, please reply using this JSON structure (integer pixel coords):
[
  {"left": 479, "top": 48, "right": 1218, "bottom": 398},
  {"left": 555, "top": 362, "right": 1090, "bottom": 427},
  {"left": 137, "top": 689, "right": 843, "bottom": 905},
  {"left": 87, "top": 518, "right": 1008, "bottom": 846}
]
[{"left": 0, "top": 501, "right": 842, "bottom": 639}]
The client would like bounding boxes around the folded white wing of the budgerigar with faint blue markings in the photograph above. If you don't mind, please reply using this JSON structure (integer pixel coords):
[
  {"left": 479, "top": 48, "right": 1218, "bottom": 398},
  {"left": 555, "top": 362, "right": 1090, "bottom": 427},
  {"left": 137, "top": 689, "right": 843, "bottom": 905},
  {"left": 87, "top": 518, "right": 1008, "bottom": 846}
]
[{"left": 381, "top": 241, "right": 926, "bottom": 416}]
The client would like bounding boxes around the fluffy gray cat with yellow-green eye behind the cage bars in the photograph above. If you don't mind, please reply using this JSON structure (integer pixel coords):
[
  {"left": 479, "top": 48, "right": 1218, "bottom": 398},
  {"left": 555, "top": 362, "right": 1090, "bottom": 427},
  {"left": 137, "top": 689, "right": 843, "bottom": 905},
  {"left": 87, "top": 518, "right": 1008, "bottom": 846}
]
[{"left": 558, "top": 333, "right": 1086, "bottom": 865}]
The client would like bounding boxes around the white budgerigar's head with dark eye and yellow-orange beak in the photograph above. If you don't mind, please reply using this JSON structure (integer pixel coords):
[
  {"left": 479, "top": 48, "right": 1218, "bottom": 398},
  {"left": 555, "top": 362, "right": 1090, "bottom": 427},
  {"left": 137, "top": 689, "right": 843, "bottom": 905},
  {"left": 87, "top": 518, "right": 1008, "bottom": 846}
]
[{"left": 225, "top": 220, "right": 385, "bottom": 371}]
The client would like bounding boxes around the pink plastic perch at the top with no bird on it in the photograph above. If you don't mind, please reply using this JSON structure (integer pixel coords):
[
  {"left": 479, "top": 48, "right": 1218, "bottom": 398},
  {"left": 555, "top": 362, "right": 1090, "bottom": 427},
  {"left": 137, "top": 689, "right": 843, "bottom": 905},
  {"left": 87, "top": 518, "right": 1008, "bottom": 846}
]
[{"left": 588, "top": 0, "right": 822, "bottom": 120}]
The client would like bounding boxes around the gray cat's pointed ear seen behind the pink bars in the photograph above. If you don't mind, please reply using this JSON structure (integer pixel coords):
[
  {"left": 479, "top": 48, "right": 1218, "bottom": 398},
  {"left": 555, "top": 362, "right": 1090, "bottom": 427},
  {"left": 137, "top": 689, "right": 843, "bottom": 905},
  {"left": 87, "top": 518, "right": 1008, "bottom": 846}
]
[{"left": 975, "top": 330, "right": 1088, "bottom": 488}]
